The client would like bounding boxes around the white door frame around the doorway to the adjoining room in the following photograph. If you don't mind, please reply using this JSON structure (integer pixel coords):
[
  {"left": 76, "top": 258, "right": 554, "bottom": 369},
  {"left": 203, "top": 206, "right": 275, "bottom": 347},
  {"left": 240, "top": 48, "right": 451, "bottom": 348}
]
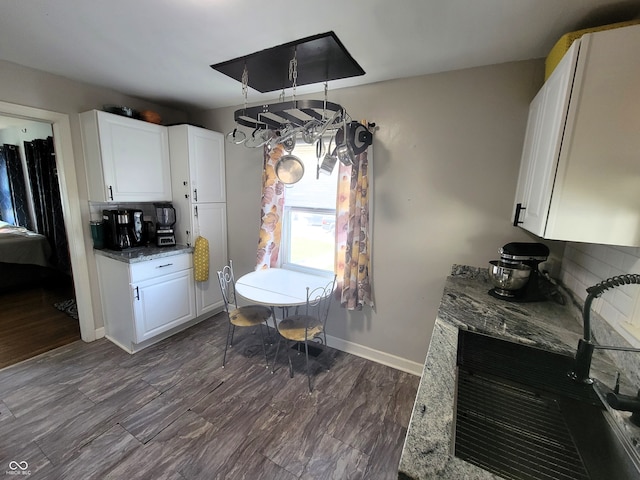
[{"left": 0, "top": 101, "right": 96, "bottom": 342}]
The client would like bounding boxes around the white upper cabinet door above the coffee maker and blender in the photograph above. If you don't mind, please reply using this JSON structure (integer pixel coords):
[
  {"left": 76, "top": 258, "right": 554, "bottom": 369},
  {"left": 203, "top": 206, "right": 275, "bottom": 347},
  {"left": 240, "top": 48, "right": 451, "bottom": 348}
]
[{"left": 96, "top": 112, "right": 171, "bottom": 202}]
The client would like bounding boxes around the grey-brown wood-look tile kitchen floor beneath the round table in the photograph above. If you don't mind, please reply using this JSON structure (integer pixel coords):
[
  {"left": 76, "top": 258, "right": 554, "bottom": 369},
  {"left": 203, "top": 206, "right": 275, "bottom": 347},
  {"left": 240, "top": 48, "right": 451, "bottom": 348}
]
[{"left": 0, "top": 315, "right": 419, "bottom": 480}]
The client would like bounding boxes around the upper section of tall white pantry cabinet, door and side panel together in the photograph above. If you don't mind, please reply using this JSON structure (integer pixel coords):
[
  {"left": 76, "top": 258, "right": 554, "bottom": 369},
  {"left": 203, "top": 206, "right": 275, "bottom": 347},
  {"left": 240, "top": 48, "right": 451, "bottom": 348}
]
[{"left": 169, "top": 125, "right": 226, "bottom": 203}]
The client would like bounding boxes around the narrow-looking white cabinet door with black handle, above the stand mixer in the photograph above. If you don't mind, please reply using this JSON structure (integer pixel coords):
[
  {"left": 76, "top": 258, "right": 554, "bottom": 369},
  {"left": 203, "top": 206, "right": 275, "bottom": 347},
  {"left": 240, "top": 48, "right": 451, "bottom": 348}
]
[{"left": 516, "top": 41, "right": 579, "bottom": 237}]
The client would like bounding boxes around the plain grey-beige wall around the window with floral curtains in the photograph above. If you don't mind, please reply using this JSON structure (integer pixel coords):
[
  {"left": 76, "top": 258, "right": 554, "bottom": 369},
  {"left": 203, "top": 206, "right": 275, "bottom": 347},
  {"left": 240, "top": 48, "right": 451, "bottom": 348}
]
[{"left": 192, "top": 60, "right": 563, "bottom": 373}]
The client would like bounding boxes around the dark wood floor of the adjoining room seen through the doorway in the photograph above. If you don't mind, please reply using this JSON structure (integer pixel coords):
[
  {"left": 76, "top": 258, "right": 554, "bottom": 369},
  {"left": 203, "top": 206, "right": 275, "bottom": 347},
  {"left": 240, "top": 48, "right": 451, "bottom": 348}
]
[{"left": 0, "top": 278, "right": 80, "bottom": 368}]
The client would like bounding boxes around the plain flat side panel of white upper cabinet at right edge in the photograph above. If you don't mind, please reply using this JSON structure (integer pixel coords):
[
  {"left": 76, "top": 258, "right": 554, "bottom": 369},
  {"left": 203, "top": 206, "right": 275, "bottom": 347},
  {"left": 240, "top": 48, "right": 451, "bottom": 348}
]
[{"left": 546, "top": 25, "right": 640, "bottom": 246}]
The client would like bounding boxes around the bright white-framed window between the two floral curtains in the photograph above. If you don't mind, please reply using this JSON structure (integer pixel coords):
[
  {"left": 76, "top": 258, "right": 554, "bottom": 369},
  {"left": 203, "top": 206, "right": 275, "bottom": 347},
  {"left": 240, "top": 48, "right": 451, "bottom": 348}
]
[{"left": 282, "top": 139, "right": 339, "bottom": 272}]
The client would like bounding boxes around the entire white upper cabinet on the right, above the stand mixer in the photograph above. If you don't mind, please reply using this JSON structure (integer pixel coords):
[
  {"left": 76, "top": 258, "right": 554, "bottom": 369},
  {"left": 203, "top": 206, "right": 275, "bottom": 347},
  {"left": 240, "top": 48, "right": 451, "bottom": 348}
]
[{"left": 513, "top": 25, "right": 640, "bottom": 246}]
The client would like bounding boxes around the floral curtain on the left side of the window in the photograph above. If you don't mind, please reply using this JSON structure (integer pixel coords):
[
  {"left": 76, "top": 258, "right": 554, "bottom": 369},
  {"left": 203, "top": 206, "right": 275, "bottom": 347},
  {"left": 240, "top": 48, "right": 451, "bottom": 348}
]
[{"left": 256, "top": 145, "right": 285, "bottom": 270}]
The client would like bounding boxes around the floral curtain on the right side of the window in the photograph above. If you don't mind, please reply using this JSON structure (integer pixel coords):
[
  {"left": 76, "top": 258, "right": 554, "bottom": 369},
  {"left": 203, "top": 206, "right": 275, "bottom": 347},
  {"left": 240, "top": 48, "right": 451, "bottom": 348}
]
[{"left": 336, "top": 151, "right": 373, "bottom": 310}]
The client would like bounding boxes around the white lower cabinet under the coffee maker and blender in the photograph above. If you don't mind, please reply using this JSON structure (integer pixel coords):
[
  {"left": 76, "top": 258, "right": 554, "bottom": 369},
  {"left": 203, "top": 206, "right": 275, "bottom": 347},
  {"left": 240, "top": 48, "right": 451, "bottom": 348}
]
[{"left": 96, "top": 253, "right": 196, "bottom": 353}]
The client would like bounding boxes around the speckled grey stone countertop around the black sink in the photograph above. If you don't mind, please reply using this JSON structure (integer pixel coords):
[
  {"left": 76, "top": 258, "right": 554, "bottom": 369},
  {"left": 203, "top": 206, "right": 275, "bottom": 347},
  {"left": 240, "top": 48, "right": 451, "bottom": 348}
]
[{"left": 398, "top": 265, "right": 640, "bottom": 480}]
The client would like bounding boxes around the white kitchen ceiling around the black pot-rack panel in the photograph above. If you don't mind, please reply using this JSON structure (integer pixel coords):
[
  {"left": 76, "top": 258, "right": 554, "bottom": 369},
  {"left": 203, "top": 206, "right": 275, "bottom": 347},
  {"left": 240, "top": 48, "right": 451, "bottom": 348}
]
[{"left": 0, "top": 0, "right": 640, "bottom": 109}]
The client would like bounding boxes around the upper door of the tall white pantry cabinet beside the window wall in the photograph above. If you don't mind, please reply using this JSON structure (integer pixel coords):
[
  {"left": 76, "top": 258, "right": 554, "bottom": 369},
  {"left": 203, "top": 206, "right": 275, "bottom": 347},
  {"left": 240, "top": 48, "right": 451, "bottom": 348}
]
[{"left": 189, "top": 127, "right": 226, "bottom": 203}]
